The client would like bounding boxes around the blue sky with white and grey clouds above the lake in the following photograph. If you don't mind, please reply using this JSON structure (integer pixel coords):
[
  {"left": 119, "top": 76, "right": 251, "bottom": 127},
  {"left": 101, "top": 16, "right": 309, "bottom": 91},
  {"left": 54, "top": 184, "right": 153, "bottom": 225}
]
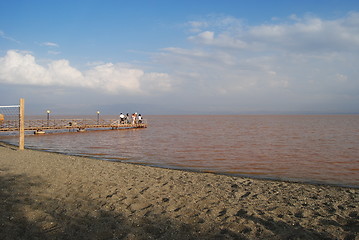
[{"left": 0, "top": 0, "right": 359, "bottom": 115}]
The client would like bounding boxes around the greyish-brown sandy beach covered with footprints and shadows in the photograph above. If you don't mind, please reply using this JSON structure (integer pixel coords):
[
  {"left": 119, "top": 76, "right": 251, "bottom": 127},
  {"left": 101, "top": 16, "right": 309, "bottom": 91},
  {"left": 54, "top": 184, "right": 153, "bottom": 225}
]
[{"left": 0, "top": 143, "right": 359, "bottom": 240}]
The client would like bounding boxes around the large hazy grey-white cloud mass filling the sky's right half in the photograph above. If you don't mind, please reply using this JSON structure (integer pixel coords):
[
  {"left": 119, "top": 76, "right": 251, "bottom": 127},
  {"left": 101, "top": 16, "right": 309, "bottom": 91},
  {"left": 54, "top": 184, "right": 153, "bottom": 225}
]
[{"left": 156, "top": 13, "right": 359, "bottom": 107}]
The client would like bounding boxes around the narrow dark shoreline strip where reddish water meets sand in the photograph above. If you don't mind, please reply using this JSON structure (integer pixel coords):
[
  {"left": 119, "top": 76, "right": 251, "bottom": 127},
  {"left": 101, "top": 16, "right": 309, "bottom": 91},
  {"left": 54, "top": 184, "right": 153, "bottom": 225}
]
[{"left": 0, "top": 140, "right": 359, "bottom": 189}]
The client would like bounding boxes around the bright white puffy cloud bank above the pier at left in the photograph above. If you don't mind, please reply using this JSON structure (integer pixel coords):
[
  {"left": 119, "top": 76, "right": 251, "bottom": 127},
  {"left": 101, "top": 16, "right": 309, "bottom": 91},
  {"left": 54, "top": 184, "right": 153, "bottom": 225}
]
[{"left": 0, "top": 50, "right": 171, "bottom": 94}]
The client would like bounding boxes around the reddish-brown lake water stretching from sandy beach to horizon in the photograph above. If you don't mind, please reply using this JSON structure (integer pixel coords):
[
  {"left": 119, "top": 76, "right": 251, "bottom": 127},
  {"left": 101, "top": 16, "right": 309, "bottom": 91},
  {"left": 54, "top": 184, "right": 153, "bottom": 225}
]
[{"left": 0, "top": 115, "right": 359, "bottom": 187}]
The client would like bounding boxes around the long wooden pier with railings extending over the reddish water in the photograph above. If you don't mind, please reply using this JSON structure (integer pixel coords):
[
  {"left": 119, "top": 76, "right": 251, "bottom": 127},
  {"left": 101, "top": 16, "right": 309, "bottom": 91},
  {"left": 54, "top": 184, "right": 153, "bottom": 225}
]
[{"left": 0, "top": 119, "right": 147, "bottom": 133}]
